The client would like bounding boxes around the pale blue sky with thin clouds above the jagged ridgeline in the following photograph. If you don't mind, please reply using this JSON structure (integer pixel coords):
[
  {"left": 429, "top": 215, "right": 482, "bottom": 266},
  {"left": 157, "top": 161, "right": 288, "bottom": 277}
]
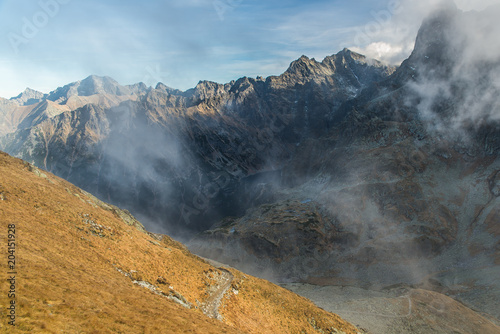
[{"left": 0, "top": 0, "right": 498, "bottom": 98}]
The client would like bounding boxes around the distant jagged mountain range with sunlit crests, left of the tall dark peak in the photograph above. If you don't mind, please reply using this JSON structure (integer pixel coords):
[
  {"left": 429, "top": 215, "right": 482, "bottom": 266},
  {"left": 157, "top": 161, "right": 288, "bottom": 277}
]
[{"left": 2, "top": 50, "right": 394, "bottom": 235}]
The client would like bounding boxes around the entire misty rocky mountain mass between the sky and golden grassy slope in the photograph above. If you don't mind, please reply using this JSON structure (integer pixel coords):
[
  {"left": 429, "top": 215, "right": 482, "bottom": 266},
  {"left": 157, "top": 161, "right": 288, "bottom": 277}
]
[{"left": 0, "top": 5, "right": 500, "bottom": 333}]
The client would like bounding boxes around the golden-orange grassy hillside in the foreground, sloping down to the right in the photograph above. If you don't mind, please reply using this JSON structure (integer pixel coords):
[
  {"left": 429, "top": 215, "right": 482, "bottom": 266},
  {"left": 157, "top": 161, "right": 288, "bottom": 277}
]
[{"left": 0, "top": 153, "right": 357, "bottom": 333}]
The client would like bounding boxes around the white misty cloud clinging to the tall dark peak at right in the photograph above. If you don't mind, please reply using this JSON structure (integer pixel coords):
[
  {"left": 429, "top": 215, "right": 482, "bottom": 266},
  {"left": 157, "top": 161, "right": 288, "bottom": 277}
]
[{"left": 411, "top": 2, "right": 500, "bottom": 139}]
